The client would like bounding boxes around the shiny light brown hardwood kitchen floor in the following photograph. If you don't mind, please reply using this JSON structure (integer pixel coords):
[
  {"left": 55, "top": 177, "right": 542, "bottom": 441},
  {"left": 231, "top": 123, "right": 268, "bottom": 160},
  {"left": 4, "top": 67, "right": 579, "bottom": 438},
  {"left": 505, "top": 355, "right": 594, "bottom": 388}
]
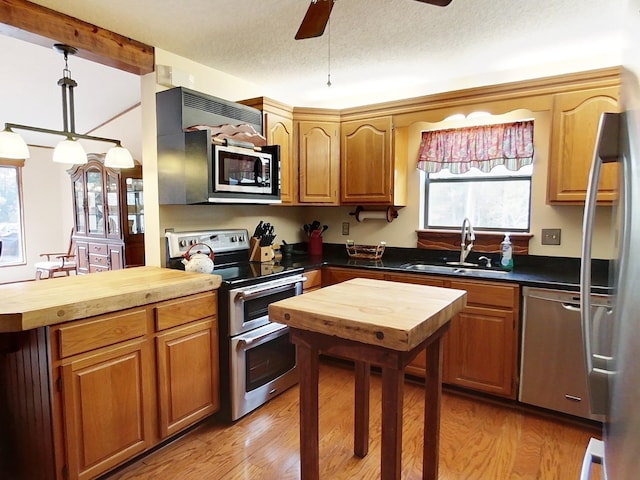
[{"left": 105, "top": 362, "right": 599, "bottom": 480}]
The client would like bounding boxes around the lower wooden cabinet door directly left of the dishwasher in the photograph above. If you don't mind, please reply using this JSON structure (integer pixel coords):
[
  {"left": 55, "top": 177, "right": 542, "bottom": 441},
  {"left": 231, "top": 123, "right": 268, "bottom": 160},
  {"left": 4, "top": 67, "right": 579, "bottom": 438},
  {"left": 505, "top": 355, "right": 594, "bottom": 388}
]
[{"left": 443, "top": 306, "right": 515, "bottom": 398}]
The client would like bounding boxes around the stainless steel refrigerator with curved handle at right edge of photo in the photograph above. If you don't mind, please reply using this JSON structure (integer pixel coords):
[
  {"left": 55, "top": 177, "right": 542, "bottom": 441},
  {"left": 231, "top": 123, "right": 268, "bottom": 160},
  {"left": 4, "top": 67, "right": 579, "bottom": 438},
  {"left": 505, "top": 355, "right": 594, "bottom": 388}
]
[{"left": 580, "top": 67, "right": 640, "bottom": 480}]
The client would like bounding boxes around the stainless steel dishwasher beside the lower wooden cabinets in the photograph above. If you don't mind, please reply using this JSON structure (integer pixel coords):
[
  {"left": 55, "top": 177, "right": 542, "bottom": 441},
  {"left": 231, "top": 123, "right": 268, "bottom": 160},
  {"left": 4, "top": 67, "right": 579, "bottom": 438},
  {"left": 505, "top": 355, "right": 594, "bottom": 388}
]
[{"left": 518, "top": 287, "right": 613, "bottom": 421}]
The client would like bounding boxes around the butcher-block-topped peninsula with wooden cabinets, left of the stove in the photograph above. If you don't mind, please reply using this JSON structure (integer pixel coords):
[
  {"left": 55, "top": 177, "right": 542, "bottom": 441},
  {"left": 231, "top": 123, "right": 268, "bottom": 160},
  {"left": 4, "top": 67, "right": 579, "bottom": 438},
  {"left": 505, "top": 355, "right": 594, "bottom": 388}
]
[{"left": 0, "top": 267, "right": 221, "bottom": 480}]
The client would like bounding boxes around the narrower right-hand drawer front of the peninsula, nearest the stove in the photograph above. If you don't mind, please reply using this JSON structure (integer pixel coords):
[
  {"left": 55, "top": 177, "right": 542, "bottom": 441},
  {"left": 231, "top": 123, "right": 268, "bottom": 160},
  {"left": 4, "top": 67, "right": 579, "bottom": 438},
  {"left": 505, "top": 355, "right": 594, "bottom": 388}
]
[{"left": 155, "top": 292, "right": 218, "bottom": 330}]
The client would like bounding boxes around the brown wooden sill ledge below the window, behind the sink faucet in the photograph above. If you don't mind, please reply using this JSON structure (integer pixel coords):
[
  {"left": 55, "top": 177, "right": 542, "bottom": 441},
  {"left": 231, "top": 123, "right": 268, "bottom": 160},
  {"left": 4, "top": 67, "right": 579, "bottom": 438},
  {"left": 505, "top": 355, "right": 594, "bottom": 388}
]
[{"left": 416, "top": 229, "right": 533, "bottom": 255}]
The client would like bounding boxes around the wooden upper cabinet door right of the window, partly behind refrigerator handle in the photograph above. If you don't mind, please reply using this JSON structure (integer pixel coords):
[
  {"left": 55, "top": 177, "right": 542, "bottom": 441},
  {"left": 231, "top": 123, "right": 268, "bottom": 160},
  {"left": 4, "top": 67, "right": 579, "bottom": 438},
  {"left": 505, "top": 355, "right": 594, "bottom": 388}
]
[{"left": 547, "top": 87, "right": 620, "bottom": 205}]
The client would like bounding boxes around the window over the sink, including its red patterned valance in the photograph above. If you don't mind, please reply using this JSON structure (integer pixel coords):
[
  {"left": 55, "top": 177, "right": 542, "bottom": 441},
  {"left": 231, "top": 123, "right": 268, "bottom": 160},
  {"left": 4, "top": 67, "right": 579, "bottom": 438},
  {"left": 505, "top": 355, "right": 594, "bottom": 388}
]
[{"left": 418, "top": 115, "right": 534, "bottom": 232}]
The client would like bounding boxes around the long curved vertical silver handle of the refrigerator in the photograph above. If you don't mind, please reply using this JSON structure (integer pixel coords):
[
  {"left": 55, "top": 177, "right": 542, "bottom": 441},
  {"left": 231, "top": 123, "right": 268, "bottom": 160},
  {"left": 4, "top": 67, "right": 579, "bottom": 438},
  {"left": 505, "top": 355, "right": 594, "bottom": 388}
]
[{"left": 580, "top": 113, "right": 619, "bottom": 415}]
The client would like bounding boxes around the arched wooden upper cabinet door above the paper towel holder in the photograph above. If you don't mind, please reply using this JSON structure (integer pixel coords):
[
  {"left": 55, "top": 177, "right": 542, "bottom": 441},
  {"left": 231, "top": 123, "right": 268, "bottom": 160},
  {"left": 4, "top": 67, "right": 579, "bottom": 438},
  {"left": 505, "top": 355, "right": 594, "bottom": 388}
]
[{"left": 340, "top": 117, "right": 394, "bottom": 204}]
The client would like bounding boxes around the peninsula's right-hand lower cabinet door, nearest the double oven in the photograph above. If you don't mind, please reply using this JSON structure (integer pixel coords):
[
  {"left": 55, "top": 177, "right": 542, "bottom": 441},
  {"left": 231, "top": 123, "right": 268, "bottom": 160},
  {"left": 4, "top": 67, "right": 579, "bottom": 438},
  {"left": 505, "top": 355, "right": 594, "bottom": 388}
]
[{"left": 156, "top": 318, "right": 220, "bottom": 438}]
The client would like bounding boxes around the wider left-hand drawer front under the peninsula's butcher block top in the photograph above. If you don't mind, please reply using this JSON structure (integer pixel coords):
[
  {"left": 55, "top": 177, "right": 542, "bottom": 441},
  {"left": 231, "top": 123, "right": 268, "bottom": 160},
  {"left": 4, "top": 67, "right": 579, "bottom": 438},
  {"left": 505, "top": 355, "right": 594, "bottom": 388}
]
[{"left": 58, "top": 308, "right": 147, "bottom": 358}]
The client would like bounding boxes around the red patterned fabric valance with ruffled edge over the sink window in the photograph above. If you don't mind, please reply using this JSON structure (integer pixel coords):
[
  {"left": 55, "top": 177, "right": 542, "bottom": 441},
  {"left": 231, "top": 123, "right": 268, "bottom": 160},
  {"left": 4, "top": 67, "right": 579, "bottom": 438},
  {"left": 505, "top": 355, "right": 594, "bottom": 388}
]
[{"left": 418, "top": 120, "right": 533, "bottom": 173}]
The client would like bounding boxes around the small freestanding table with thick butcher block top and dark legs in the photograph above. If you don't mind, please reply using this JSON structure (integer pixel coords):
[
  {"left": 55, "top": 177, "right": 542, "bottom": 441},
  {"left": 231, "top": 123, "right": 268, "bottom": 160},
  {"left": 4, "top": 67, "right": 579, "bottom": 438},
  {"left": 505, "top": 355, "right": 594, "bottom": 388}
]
[{"left": 269, "top": 278, "right": 466, "bottom": 480}]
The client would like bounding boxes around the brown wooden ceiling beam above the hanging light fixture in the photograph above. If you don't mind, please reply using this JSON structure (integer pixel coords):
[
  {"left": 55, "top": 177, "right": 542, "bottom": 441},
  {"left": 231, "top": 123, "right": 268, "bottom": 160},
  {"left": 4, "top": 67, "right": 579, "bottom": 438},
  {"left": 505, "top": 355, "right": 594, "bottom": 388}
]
[{"left": 0, "top": 0, "right": 155, "bottom": 75}]
